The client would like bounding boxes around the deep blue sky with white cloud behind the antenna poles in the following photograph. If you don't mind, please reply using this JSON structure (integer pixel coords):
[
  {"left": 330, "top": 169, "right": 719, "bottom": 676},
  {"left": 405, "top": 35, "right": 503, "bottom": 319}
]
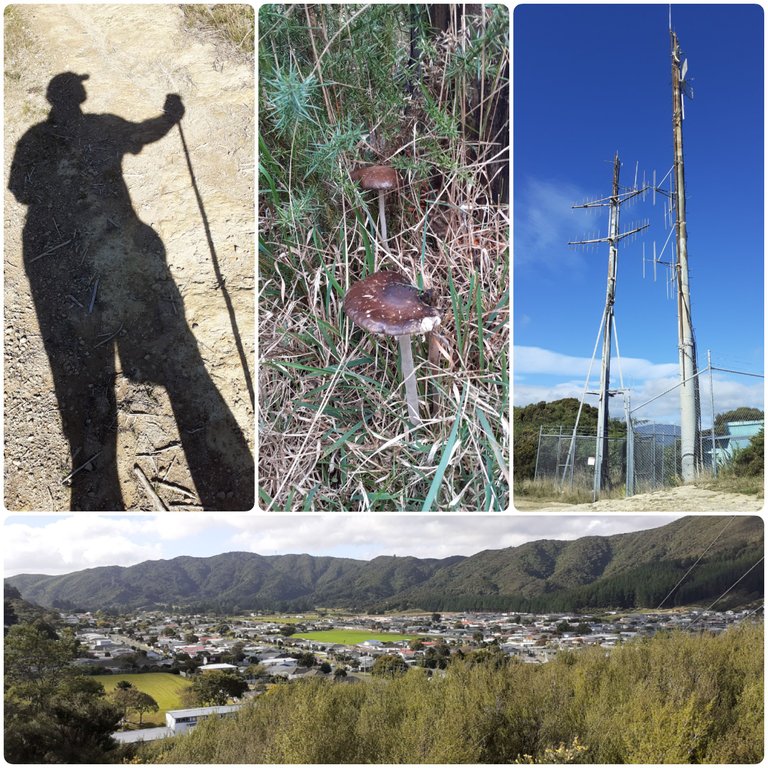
[{"left": 513, "top": 4, "right": 764, "bottom": 426}]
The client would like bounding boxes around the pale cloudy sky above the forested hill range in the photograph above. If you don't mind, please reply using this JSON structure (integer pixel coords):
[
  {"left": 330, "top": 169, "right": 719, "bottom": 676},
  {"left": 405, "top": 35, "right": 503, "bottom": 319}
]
[{"left": 3, "top": 512, "right": 683, "bottom": 576}]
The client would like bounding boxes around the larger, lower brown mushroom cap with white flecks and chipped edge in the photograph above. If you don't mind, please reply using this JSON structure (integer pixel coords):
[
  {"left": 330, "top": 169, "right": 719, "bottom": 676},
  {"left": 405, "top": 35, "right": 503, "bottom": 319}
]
[{"left": 344, "top": 272, "right": 440, "bottom": 336}]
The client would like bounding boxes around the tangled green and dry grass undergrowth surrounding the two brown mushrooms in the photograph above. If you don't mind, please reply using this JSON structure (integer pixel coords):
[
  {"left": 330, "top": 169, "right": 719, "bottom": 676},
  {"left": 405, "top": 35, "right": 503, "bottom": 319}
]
[{"left": 258, "top": 4, "right": 509, "bottom": 511}]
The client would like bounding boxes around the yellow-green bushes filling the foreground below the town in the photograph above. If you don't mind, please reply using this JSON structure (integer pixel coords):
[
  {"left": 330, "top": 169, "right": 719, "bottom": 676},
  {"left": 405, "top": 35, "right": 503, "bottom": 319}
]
[{"left": 140, "top": 624, "right": 763, "bottom": 763}]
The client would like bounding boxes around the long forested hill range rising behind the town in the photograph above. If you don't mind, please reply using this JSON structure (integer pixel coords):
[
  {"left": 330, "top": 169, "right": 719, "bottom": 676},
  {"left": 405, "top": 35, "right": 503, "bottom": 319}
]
[{"left": 6, "top": 516, "right": 763, "bottom": 612}]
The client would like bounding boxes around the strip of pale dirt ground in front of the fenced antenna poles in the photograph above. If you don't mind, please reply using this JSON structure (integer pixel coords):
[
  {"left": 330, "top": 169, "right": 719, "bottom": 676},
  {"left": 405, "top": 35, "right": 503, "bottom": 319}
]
[{"left": 514, "top": 486, "right": 765, "bottom": 512}]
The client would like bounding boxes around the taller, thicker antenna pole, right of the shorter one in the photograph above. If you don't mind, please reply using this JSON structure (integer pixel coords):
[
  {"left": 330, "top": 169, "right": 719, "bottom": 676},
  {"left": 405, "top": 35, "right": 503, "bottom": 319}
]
[{"left": 669, "top": 31, "right": 699, "bottom": 483}]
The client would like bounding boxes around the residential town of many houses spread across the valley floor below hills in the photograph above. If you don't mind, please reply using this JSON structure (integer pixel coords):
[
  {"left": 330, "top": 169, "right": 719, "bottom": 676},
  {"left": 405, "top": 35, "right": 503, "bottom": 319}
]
[{"left": 70, "top": 610, "right": 752, "bottom": 680}]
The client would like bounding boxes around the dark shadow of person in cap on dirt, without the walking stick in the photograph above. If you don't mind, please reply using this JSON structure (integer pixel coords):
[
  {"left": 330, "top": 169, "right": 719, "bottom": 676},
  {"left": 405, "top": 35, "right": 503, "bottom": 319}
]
[{"left": 9, "top": 72, "right": 254, "bottom": 510}]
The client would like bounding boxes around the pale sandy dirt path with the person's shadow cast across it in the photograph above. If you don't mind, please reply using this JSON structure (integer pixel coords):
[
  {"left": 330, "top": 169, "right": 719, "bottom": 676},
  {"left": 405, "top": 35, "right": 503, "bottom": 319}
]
[{"left": 4, "top": 4, "right": 254, "bottom": 511}]
